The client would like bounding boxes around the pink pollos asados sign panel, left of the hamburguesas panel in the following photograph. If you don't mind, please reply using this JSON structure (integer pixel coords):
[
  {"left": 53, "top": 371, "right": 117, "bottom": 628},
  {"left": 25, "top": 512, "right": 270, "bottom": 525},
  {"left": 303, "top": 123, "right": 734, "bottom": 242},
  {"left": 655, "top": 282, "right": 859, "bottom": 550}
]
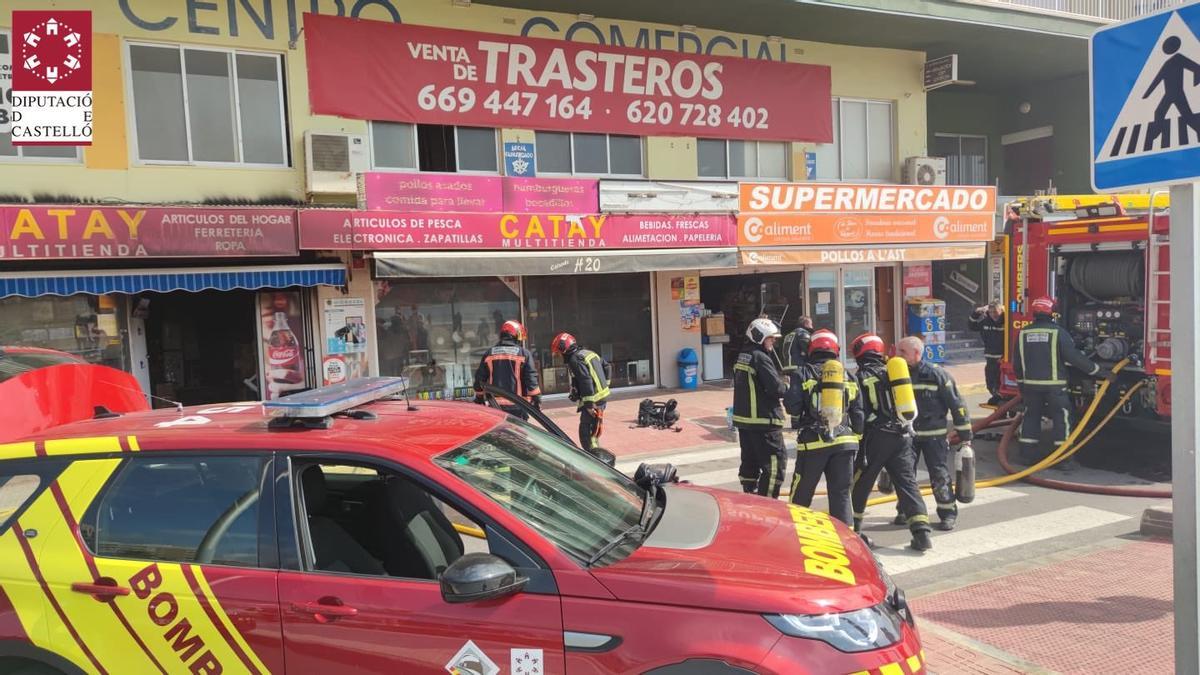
[{"left": 359, "top": 172, "right": 504, "bottom": 213}]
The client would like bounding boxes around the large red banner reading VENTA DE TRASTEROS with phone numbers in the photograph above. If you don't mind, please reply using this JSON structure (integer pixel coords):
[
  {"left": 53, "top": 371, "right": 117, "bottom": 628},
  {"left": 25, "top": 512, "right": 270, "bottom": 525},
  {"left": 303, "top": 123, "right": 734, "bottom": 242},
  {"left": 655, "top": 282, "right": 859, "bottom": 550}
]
[{"left": 305, "top": 14, "right": 833, "bottom": 143}]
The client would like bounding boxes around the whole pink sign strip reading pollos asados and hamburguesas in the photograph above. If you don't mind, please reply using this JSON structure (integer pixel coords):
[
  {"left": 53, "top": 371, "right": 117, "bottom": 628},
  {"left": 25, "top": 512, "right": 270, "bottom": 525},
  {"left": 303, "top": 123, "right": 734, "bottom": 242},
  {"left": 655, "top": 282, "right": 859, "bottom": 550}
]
[{"left": 359, "top": 172, "right": 600, "bottom": 214}]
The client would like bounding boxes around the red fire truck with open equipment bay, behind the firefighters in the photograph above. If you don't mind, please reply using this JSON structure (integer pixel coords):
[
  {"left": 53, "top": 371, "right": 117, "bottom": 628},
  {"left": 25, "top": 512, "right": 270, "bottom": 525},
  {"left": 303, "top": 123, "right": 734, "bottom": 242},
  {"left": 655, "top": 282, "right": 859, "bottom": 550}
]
[{"left": 1001, "top": 192, "right": 1171, "bottom": 423}]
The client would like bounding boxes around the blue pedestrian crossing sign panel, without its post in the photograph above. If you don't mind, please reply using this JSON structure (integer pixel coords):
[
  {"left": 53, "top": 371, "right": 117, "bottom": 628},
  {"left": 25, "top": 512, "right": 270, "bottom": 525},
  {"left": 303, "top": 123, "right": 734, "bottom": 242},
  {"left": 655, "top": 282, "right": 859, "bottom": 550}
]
[{"left": 1090, "top": 2, "right": 1200, "bottom": 192}]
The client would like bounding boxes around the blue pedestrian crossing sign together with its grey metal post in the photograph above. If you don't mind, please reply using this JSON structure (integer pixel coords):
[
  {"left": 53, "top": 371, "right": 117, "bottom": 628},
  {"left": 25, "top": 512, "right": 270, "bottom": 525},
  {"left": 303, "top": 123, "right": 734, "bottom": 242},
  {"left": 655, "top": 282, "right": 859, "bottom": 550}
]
[{"left": 1090, "top": 2, "right": 1200, "bottom": 675}]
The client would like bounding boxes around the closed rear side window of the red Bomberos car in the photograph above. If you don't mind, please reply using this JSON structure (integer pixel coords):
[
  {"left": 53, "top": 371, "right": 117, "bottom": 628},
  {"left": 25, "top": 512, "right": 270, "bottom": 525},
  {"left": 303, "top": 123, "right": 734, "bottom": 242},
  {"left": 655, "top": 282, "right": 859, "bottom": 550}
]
[{"left": 79, "top": 455, "right": 268, "bottom": 567}]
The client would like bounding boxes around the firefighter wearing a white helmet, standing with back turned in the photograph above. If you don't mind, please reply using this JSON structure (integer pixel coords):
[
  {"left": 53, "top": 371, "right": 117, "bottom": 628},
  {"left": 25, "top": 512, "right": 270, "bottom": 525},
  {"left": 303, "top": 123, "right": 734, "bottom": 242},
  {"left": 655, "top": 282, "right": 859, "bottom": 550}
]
[{"left": 733, "top": 318, "right": 787, "bottom": 498}]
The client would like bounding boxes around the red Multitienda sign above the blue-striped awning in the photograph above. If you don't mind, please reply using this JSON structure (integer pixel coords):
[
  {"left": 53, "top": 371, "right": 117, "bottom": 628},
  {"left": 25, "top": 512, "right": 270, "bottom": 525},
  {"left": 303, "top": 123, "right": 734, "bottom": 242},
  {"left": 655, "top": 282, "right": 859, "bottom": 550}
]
[{"left": 0, "top": 205, "right": 298, "bottom": 259}]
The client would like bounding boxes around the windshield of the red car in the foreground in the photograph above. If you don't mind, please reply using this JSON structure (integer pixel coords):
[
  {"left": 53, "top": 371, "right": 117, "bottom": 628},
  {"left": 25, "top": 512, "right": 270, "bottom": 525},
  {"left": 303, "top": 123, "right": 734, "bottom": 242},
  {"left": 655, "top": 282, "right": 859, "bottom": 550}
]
[{"left": 434, "top": 420, "right": 644, "bottom": 562}]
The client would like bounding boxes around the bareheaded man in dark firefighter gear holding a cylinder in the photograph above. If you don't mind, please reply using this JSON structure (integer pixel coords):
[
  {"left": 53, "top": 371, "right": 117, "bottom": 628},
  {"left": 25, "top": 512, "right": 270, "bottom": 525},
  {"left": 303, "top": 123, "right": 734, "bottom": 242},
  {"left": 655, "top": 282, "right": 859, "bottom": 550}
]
[{"left": 896, "top": 336, "right": 971, "bottom": 531}]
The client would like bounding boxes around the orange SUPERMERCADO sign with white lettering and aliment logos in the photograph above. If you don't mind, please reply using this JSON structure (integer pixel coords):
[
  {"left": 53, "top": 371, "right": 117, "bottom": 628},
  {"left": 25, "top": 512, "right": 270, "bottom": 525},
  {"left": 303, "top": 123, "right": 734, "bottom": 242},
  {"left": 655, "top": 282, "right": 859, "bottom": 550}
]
[{"left": 738, "top": 183, "right": 996, "bottom": 246}]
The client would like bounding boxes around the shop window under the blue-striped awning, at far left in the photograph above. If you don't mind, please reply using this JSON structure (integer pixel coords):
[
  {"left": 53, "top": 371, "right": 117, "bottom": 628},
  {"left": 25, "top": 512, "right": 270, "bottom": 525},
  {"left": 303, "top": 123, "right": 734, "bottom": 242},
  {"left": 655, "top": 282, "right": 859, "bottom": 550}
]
[{"left": 0, "top": 295, "right": 130, "bottom": 371}]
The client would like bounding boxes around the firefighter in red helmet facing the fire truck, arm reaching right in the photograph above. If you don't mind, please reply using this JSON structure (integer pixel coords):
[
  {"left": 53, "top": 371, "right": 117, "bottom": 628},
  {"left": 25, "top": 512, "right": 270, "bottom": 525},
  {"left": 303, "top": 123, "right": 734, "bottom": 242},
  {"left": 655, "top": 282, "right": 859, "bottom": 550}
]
[{"left": 1013, "top": 297, "right": 1115, "bottom": 465}]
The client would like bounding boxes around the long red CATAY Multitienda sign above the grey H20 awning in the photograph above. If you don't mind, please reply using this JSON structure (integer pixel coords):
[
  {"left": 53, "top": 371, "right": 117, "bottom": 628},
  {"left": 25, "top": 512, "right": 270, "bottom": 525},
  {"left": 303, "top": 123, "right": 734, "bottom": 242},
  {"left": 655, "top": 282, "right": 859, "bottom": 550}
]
[{"left": 300, "top": 209, "right": 737, "bottom": 251}]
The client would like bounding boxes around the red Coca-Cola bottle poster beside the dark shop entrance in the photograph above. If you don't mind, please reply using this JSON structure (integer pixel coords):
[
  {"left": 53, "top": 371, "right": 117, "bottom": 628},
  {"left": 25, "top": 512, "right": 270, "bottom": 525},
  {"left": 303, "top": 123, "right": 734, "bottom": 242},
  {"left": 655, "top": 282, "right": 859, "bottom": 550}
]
[{"left": 258, "top": 291, "right": 310, "bottom": 401}]
